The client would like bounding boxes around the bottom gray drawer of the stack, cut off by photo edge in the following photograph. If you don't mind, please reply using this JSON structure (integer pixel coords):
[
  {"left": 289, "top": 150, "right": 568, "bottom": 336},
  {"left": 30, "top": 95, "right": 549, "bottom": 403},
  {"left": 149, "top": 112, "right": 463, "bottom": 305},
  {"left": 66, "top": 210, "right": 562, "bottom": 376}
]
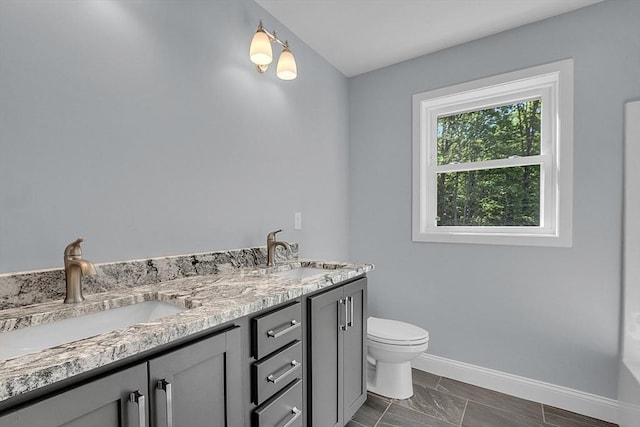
[{"left": 253, "top": 379, "right": 303, "bottom": 427}]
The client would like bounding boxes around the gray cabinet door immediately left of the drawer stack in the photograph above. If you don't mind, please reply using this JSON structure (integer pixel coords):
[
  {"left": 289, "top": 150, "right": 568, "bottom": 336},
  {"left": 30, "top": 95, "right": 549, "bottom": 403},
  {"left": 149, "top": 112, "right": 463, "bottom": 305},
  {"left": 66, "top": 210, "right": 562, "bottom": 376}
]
[{"left": 149, "top": 328, "right": 244, "bottom": 427}]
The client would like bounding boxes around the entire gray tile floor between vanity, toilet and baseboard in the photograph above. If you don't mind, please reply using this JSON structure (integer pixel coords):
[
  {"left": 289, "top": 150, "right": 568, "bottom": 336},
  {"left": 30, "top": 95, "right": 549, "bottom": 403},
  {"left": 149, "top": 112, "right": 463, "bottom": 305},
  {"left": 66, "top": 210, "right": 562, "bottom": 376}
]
[{"left": 347, "top": 370, "right": 615, "bottom": 427}]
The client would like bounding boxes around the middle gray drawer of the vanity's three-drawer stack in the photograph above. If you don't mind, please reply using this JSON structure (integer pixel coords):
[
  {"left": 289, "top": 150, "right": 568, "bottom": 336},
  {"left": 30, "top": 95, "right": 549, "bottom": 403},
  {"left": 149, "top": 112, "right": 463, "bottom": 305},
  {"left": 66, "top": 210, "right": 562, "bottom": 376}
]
[{"left": 251, "top": 341, "right": 302, "bottom": 405}]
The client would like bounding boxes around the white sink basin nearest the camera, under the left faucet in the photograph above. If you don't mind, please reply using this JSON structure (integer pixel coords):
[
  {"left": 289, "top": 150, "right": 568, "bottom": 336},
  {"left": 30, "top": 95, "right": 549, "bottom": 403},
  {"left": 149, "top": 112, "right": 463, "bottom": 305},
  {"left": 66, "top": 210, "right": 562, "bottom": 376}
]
[{"left": 0, "top": 301, "right": 186, "bottom": 360}]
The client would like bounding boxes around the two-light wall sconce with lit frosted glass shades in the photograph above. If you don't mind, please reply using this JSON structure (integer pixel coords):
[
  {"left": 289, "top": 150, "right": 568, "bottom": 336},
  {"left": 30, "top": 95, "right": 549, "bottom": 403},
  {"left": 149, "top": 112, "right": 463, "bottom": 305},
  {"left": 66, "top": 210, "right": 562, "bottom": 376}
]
[{"left": 249, "top": 21, "right": 298, "bottom": 80}]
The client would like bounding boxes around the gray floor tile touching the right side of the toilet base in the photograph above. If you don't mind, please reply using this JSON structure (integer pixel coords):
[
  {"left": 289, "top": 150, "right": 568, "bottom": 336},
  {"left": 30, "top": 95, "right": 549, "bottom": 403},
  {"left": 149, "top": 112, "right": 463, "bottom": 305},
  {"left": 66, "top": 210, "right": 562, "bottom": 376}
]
[{"left": 394, "top": 384, "right": 466, "bottom": 424}]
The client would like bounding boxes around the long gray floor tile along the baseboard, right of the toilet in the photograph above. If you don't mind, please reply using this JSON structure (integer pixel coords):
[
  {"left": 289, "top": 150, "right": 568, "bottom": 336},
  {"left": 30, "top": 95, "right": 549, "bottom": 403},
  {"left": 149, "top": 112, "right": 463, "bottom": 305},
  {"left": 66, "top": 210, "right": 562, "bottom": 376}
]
[{"left": 437, "top": 378, "right": 543, "bottom": 422}]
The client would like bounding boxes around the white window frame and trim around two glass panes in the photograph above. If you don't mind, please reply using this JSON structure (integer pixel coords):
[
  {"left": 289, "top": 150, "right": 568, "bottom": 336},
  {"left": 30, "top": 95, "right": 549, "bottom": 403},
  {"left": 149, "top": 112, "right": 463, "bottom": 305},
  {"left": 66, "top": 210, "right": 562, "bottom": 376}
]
[{"left": 412, "top": 59, "right": 573, "bottom": 247}]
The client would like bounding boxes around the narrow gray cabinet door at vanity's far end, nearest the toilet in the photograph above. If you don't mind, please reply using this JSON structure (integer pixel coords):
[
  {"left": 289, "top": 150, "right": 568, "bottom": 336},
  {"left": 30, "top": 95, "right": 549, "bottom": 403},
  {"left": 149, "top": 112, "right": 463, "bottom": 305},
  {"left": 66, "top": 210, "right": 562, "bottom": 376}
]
[{"left": 343, "top": 279, "right": 367, "bottom": 424}]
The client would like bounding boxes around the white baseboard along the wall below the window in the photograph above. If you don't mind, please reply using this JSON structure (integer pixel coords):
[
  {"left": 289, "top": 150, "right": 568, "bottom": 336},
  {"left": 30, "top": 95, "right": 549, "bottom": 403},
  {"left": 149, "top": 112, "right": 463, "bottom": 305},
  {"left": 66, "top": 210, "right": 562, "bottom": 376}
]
[{"left": 412, "top": 353, "right": 620, "bottom": 423}]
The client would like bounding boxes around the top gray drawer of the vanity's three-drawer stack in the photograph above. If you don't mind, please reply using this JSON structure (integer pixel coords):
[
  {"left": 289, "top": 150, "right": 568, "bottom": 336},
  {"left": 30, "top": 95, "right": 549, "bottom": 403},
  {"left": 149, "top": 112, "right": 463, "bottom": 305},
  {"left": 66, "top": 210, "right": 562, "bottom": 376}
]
[{"left": 251, "top": 302, "right": 302, "bottom": 359}]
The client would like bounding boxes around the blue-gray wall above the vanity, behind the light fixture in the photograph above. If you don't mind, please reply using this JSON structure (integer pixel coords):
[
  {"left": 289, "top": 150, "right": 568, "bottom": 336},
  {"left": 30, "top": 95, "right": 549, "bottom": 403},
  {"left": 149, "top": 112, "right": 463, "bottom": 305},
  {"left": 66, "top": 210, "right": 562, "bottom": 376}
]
[{"left": 0, "top": 0, "right": 348, "bottom": 272}]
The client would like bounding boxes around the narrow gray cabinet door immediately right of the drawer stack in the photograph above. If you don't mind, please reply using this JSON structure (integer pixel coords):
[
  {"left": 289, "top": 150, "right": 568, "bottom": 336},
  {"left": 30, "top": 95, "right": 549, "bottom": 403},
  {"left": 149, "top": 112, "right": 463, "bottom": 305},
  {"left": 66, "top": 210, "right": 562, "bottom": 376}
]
[{"left": 307, "top": 287, "right": 345, "bottom": 427}]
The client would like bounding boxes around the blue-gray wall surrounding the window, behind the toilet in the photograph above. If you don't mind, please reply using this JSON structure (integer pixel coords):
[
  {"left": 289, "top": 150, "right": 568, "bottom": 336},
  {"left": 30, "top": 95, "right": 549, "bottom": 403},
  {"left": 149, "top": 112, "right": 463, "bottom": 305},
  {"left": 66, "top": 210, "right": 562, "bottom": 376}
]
[{"left": 349, "top": 0, "right": 640, "bottom": 398}]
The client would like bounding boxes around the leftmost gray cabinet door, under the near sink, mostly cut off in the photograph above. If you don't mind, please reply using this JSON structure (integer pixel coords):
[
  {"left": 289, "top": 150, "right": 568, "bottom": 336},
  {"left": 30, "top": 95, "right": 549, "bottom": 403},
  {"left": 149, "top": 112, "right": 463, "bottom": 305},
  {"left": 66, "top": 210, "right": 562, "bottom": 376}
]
[{"left": 0, "top": 363, "right": 148, "bottom": 427}]
